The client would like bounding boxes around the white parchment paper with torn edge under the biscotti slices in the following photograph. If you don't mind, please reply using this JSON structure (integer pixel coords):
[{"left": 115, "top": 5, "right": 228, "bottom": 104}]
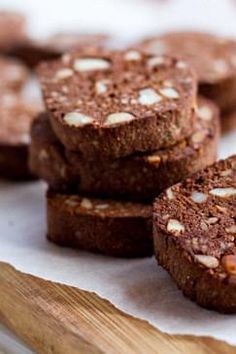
[{"left": 0, "top": 132, "right": 236, "bottom": 345}]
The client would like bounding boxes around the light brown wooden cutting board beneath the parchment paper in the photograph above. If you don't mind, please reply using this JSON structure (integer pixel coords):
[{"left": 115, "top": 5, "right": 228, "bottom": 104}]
[{"left": 0, "top": 262, "right": 236, "bottom": 354}]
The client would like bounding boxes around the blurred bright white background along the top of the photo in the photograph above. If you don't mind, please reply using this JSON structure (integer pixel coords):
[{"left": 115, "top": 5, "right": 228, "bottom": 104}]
[{"left": 0, "top": 0, "right": 236, "bottom": 37}]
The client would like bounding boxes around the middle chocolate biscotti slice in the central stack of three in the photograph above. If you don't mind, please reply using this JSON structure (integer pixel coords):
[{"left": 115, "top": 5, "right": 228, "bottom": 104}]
[{"left": 29, "top": 99, "right": 219, "bottom": 201}]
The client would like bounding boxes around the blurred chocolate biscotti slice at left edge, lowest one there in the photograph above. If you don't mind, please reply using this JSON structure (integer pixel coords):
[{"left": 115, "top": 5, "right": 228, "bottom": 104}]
[{"left": 0, "top": 93, "right": 38, "bottom": 180}]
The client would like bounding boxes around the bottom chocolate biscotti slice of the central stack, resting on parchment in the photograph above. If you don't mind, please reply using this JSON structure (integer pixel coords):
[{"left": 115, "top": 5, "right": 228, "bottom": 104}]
[{"left": 47, "top": 191, "right": 153, "bottom": 257}]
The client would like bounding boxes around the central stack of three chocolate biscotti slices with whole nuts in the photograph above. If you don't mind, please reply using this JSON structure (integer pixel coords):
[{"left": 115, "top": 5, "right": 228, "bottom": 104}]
[{"left": 30, "top": 49, "right": 219, "bottom": 257}]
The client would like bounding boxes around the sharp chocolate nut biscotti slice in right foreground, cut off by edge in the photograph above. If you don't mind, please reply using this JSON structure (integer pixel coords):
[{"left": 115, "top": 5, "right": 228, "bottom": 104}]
[{"left": 153, "top": 155, "right": 236, "bottom": 313}]
